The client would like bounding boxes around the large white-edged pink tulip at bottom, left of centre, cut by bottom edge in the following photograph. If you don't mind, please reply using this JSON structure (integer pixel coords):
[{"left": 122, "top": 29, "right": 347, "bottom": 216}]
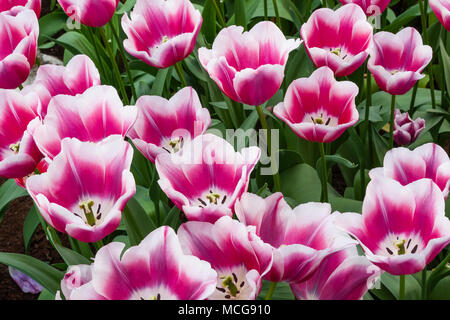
[{"left": 86, "top": 227, "right": 217, "bottom": 300}]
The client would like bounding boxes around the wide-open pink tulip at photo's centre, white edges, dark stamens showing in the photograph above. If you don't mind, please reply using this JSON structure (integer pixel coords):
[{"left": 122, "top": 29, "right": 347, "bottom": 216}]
[{"left": 155, "top": 134, "right": 261, "bottom": 222}]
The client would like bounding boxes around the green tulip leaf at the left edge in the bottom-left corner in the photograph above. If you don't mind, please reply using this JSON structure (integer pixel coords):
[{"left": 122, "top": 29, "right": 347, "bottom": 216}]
[{"left": 0, "top": 252, "right": 64, "bottom": 294}]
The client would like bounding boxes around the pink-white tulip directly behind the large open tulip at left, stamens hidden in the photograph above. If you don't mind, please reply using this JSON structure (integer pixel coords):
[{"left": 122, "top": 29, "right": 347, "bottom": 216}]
[{"left": 33, "top": 86, "right": 137, "bottom": 159}]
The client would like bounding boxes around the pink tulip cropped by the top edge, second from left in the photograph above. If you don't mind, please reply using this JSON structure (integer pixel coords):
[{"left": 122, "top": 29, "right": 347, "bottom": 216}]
[{"left": 58, "top": 0, "right": 119, "bottom": 27}]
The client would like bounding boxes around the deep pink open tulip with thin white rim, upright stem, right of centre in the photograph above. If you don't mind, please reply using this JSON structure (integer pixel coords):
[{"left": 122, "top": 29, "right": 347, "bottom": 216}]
[{"left": 273, "top": 67, "right": 359, "bottom": 142}]
